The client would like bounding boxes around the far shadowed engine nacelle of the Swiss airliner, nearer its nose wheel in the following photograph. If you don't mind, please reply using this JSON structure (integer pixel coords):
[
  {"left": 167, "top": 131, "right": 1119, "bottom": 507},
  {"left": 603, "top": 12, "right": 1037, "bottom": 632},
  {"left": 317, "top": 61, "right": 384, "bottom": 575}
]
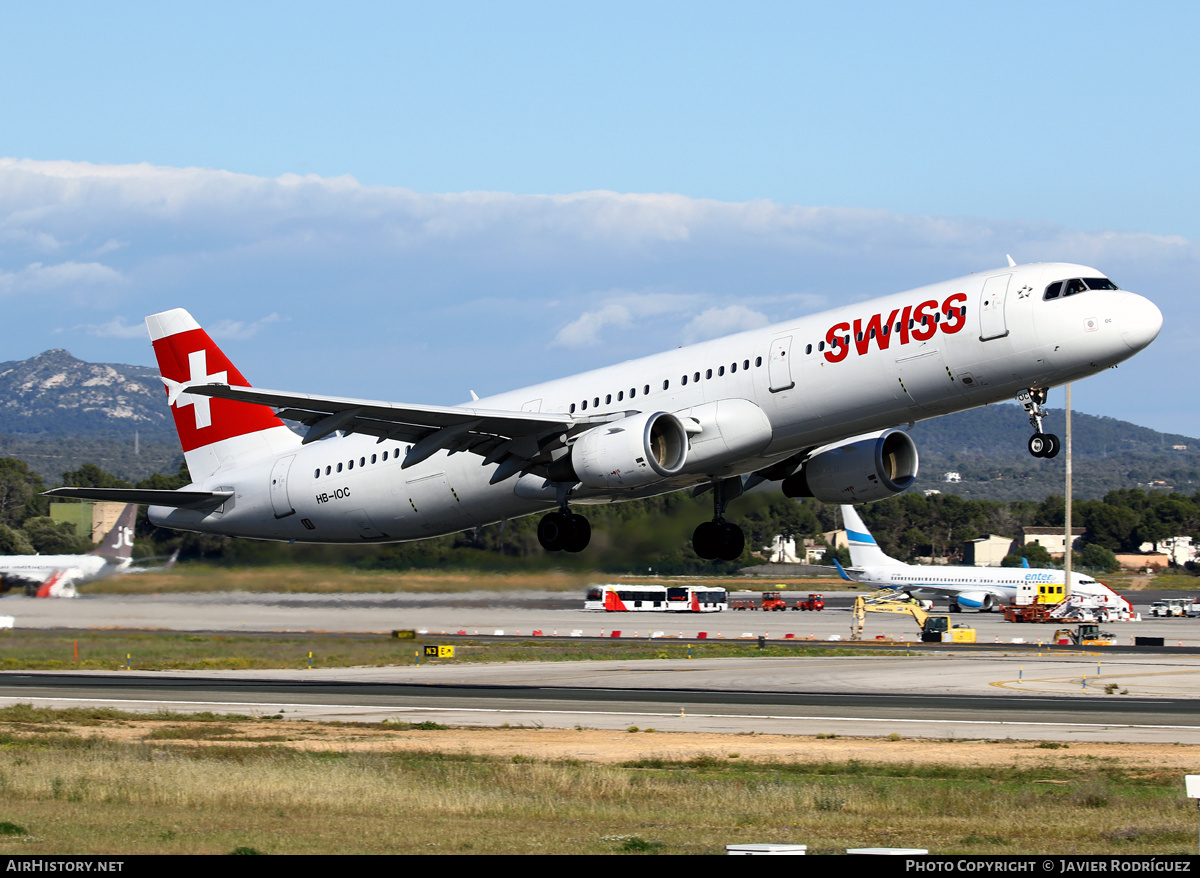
[{"left": 782, "top": 429, "right": 918, "bottom": 504}]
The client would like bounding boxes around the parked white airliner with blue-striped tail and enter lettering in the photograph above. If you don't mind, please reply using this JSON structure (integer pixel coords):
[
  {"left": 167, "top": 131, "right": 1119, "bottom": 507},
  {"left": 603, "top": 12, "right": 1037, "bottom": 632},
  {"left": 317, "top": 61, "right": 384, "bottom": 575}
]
[{"left": 835, "top": 506, "right": 1133, "bottom": 621}]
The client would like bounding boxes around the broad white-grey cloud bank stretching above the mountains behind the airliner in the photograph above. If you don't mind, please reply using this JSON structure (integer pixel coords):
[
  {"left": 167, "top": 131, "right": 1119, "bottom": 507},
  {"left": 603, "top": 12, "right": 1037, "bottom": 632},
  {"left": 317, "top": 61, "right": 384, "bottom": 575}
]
[{"left": 0, "top": 158, "right": 1200, "bottom": 433}]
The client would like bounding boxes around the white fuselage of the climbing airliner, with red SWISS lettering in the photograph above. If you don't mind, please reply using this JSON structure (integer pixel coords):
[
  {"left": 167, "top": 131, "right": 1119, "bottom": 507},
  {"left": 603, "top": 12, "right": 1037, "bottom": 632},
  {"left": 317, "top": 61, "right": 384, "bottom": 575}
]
[{"left": 150, "top": 264, "right": 1160, "bottom": 542}]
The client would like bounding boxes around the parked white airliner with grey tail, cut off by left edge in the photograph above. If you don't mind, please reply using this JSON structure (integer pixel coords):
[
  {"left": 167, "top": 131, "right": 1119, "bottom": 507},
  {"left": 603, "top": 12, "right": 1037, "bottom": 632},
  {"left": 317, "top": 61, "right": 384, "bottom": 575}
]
[{"left": 0, "top": 504, "right": 138, "bottom": 597}]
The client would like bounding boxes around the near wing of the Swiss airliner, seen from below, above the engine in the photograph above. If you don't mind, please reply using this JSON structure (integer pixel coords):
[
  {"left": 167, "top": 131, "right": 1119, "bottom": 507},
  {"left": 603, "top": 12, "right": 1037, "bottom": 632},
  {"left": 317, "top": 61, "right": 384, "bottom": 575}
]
[{"left": 184, "top": 384, "right": 636, "bottom": 482}]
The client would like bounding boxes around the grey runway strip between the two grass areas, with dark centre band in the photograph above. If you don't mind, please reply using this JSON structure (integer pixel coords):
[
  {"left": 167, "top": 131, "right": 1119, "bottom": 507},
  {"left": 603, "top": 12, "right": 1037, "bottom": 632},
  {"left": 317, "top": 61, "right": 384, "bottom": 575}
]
[{"left": 0, "top": 656, "right": 1200, "bottom": 744}]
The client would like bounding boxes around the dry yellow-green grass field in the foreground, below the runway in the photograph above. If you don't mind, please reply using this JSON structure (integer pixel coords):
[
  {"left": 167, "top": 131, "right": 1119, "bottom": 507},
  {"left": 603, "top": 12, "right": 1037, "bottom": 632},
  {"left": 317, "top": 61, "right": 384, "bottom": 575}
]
[{"left": 0, "top": 705, "right": 1196, "bottom": 854}]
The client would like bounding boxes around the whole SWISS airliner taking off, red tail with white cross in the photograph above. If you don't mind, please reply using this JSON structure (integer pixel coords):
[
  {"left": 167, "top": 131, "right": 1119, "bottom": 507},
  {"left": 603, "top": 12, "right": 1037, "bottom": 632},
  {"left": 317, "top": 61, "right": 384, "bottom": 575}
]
[{"left": 49, "top": 259, "right": 1163, "bottom": 560}]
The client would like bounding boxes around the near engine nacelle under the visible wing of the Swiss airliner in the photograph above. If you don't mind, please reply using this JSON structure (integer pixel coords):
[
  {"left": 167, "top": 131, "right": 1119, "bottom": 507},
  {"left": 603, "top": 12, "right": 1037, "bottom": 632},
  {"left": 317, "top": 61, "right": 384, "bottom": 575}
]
[{"left": 569, "top": 411, "right": 688, "bottom": 488}]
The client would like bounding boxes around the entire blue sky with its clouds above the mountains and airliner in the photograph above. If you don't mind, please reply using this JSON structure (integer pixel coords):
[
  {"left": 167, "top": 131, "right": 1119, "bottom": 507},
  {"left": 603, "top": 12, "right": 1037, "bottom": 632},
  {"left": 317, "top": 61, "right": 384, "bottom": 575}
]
[{"left": 0, "top": 2, "right": 1200, "bottom": 435}]
